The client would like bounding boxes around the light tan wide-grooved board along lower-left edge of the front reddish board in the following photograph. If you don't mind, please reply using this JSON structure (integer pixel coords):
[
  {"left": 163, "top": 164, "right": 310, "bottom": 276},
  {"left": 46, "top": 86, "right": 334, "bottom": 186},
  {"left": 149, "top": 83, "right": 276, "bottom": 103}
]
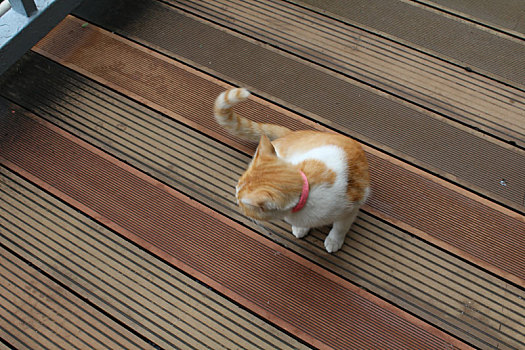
[{"left": 0, "top": 168, "right": 306, "bottom": 349}]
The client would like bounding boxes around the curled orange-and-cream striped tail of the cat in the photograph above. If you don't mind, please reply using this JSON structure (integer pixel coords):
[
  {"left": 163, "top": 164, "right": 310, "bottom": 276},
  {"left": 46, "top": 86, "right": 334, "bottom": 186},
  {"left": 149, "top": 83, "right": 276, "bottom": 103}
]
[{"left": 215, "top": 88, "right": 290, "bottom": 142}]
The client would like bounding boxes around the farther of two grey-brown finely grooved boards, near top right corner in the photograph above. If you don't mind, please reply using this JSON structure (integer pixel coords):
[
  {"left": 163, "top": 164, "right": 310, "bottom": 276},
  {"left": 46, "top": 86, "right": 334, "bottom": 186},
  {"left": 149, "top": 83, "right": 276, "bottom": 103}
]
[{"left": 295, "top": 0, "right": 525, "bottom": 89}]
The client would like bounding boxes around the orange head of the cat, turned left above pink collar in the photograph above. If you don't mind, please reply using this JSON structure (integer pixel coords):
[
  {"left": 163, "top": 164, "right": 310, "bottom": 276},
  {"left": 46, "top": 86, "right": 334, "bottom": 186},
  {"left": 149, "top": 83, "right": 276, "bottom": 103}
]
[{"left": 236, "top": 135, "right": 302, "bottom": 221}]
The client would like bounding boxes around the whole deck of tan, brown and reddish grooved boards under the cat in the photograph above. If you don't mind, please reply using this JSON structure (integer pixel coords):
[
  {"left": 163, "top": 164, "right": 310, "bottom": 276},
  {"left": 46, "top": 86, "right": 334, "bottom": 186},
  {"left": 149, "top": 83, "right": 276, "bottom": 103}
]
[{"left": 0, "top": 0, "right": 525, "bottom": 349}]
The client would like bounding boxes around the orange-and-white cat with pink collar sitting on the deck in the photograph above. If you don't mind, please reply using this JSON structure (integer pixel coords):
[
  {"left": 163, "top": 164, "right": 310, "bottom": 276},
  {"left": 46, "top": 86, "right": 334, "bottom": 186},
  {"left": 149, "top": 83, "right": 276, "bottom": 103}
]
[{"left": 214, "top": 88, "right": 370, "bottom": 253}]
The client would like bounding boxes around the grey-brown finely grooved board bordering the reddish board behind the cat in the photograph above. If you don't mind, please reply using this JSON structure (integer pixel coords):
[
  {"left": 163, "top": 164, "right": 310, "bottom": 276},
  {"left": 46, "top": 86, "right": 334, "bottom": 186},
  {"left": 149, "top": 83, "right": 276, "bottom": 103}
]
[{"left": 71, "top": 0, "right": 525, "bottom": 210}]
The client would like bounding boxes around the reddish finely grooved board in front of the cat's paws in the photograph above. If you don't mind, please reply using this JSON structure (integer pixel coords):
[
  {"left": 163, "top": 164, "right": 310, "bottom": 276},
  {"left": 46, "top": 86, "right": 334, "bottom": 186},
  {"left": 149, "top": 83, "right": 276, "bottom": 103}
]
[{"left": 0, "top": 102, "right": 468, "bottom": 349}]
